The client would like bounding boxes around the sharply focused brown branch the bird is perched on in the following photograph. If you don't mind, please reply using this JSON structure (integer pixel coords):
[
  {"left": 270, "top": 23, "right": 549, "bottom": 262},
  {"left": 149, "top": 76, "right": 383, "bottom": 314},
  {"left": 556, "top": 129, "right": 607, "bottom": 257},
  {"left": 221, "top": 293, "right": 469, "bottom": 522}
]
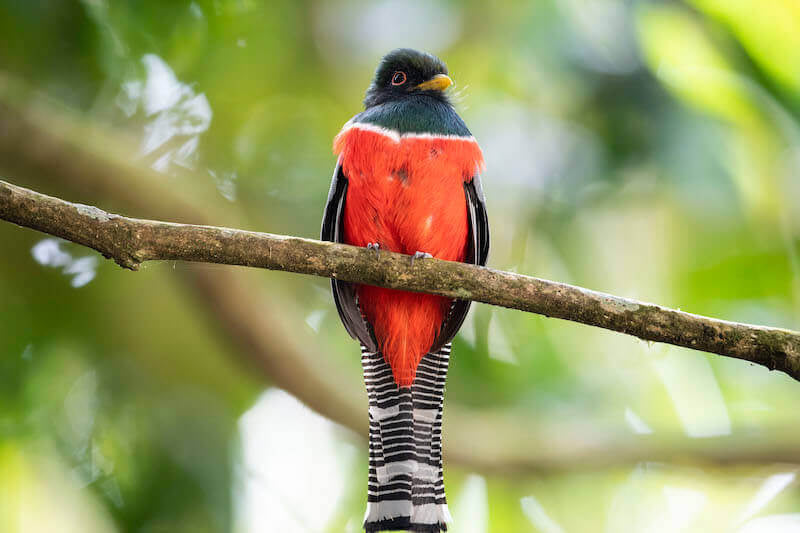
[{"left": 0, "top": 181, "right": 800, "bottom": 380}]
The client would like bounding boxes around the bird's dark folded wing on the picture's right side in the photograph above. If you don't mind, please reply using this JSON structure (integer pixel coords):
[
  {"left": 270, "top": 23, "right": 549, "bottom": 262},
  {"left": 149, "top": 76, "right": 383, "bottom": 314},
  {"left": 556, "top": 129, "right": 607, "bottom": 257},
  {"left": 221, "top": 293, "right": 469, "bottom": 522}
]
[{"left": 430, "top": 174, "right": 489, "bottom": 352}]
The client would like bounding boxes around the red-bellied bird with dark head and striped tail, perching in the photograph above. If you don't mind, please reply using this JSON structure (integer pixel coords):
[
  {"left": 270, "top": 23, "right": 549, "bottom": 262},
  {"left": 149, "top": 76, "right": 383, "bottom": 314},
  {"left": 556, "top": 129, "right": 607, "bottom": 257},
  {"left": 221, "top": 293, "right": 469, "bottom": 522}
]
[{"left": 321, "top": 48, "right": 489, "bottom": 533}]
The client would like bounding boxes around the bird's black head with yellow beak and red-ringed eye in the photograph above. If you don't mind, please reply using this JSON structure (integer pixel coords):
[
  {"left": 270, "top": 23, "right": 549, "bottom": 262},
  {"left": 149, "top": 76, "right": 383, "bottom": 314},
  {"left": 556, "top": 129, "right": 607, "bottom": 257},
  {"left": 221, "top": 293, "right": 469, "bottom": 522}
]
[{"left": 364, "top": 48, "right": 453, "bottom": 108}]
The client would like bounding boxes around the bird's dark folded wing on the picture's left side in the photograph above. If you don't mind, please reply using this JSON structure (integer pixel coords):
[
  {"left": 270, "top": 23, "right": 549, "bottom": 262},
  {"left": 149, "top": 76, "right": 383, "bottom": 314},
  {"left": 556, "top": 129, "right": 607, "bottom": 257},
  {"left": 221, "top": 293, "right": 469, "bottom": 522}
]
[{"left": 321, "top": 162, "right": 377, "bottom": 352}]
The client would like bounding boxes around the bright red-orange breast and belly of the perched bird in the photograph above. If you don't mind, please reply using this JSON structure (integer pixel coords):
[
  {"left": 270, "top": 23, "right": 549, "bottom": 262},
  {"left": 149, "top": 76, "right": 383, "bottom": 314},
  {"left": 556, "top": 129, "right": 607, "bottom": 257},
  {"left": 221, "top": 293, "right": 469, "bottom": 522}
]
[{"left": 335, "top": 123, "right": 482, "bottom": 387}]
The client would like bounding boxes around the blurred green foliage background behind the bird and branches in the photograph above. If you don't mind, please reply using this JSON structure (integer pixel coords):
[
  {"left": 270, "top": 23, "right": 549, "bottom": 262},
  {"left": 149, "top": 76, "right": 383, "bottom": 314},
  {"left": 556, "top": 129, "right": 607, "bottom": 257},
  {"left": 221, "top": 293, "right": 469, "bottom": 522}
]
[{"left": 0, "top": 0, "right": 800, "bottom": 533}]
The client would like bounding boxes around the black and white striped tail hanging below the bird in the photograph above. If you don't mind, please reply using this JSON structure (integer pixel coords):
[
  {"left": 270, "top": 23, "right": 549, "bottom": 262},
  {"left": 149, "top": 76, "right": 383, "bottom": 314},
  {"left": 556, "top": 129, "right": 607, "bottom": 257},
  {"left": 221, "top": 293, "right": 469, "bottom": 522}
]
[{"left": 361, "top": 344, "right": 452, "bottom": 533}]
